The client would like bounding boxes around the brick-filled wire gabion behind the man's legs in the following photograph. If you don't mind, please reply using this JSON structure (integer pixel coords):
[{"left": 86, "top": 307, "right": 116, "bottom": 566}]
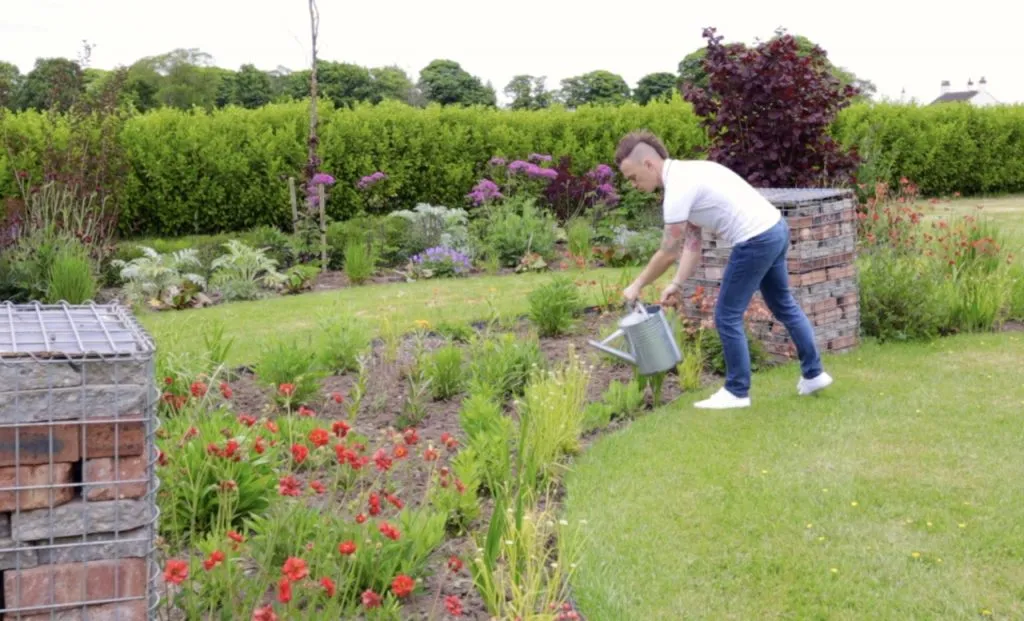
[{"left": 684, "top": 189, "right": 860, "bottom": 359}]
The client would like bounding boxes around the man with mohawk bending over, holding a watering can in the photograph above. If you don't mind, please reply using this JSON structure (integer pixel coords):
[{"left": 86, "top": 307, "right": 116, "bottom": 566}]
[{"left": 615, "top": 131, "right": 833, "bottom": 409}]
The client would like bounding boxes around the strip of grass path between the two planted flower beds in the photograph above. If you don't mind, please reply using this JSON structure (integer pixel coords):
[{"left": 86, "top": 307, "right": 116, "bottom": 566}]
[{"left": 139, "top": 270, "right": 643, "bottom": 365}]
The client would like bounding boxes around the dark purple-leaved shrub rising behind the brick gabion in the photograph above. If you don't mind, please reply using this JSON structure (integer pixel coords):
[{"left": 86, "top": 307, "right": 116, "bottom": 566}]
[{"left": 684, "top": 28, "right": 857, "bottom": 188}]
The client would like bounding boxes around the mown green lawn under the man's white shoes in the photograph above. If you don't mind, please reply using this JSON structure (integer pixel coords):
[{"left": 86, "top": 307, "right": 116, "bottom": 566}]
[{"left": 566, "top": 333, "right": 1024, "bottom": 621}]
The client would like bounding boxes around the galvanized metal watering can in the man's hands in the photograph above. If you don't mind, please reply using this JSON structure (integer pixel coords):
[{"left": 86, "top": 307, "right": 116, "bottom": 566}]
[{"left": 588, "top": 302, "right": 683, "bottom": 375}]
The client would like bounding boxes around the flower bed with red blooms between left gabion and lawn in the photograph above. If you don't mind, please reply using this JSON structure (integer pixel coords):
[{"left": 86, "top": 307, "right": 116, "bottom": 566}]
[{"left": 151, "top": 289, "right": 716, "bottom": 619}]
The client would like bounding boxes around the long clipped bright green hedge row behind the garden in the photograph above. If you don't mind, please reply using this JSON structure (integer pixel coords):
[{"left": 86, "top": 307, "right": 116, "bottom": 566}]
[{"left": 0, "top": 97, "right": 1024, "bottom": 236}]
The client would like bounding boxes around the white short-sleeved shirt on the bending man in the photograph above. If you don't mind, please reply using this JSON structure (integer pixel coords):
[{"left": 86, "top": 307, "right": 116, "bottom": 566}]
[{"left": 662, "top": 160, "right": 782, "bottom": 245}]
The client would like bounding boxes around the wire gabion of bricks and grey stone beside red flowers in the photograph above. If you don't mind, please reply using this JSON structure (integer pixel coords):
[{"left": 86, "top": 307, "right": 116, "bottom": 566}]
[{"left": 0, "top": 302, "right": 159, "bottom": 621}]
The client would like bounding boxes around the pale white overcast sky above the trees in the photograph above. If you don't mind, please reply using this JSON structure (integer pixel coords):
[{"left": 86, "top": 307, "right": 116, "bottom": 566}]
[{"left": 0, "top": 0, "right": 1024, "bottom": 102}]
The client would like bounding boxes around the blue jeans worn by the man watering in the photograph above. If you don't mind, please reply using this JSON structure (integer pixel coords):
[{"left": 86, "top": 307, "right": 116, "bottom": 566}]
[{"left": 715, "top": 218, "right": 822, "bottom": 398}]
